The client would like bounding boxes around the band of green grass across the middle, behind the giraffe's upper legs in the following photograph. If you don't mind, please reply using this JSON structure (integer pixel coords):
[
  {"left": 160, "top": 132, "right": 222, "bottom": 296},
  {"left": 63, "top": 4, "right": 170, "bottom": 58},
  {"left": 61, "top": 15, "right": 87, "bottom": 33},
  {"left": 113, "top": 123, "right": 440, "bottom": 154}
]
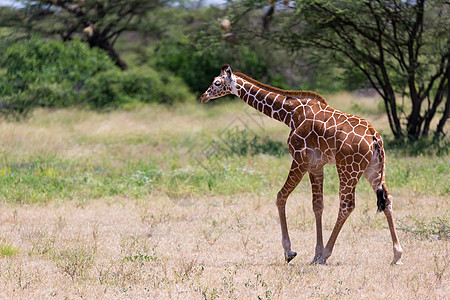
[{"left": 0, "top": 136, "right": 450, "bottom": 205}]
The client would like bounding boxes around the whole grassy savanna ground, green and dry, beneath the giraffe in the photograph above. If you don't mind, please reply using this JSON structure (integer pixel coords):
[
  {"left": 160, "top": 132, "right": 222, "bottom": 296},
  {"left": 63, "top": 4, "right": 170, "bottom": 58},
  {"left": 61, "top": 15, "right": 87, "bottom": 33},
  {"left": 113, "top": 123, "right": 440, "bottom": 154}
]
[{"left": 0, "top": 94, "right": 450, "bottom": 299}]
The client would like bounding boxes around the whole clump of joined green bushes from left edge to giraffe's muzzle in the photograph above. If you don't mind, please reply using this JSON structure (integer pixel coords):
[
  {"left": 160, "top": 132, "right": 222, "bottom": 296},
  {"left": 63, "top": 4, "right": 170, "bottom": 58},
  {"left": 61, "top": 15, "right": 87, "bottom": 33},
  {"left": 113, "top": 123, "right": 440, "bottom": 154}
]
[{"left": 0, "top": 39, "right": 193, "bottom": 118}]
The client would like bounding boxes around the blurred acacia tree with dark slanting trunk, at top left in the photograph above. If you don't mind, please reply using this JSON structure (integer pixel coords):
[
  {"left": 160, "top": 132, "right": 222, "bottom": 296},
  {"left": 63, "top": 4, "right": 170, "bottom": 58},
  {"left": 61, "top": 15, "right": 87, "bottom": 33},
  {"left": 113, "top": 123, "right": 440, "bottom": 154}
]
[{"left": 17, "top": 0, "right": 167, "bottom": 69}]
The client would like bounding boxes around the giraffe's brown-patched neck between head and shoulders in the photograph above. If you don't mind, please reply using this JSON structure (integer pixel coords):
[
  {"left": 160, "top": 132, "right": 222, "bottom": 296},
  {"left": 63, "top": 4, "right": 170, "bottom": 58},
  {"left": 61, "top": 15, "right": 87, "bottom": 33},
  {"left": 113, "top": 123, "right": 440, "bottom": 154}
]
[{"left": 232, "top": 74, "right": 299, "bottom": 129}]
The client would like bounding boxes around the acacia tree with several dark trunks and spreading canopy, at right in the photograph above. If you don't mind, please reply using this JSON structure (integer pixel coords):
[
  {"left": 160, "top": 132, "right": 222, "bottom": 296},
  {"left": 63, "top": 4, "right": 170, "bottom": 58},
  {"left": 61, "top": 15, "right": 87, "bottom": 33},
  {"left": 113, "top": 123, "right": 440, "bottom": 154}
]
[{"left": 230, "top": 0, "right": 450, "bottom": 140}]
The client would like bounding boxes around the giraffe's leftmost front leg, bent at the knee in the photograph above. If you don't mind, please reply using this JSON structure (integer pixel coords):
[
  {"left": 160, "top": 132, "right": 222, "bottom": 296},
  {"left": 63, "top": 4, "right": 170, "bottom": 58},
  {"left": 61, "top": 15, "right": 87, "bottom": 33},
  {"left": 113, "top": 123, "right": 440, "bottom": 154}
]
[{"left": 277, "top": 160, "right": 305, "bottom": 263}]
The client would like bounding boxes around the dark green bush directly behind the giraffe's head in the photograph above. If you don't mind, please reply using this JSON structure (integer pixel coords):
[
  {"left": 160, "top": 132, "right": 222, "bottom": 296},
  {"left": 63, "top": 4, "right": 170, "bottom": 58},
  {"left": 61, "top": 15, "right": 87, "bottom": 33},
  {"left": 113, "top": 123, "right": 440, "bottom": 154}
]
[{"left": 152, "top": 39, "right": 296, "bottom": 94}]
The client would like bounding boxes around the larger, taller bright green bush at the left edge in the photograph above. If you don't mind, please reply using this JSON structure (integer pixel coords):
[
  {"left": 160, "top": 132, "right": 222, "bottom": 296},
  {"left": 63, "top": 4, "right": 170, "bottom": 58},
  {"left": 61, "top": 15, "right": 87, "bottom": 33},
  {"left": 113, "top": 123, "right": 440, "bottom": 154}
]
[{"left": 0, "top": 39, "right": 115, "bottom": 116}]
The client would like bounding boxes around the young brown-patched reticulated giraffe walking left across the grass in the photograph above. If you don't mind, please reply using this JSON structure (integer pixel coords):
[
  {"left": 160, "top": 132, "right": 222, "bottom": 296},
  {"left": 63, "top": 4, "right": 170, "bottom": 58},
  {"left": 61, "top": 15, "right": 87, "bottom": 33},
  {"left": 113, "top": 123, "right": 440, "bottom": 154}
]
[{"left": 200, "top": 65, "right": 403, "bottom": 264}]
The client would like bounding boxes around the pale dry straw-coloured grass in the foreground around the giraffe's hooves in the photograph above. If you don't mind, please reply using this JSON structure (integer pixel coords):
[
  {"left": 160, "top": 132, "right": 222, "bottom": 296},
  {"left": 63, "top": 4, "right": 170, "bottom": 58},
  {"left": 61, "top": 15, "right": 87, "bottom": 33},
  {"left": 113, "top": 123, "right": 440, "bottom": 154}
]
[{"left": 0, "top": 193, "right": 450, "bottom": 299}]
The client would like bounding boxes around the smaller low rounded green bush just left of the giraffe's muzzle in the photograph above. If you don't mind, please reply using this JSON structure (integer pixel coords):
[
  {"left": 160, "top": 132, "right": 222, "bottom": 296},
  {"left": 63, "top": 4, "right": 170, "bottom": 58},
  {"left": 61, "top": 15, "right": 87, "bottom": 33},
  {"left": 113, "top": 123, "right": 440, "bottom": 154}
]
[{"left": 84, "top": 67, "right": 194, "bottom": 109}]
